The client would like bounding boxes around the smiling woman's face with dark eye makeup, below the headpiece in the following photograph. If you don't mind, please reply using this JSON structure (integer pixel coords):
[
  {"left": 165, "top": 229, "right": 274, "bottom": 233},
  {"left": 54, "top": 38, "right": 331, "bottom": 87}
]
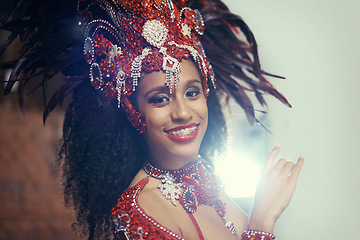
[{"left": 136, "top": 60, "right": 208, "bottom": 169}]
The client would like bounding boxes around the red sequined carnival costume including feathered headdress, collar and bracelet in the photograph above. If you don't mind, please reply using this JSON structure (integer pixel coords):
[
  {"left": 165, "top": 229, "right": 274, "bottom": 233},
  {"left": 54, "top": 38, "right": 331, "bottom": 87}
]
[{"left": 0, "top": 0, "right": 290, "bottom": 240}]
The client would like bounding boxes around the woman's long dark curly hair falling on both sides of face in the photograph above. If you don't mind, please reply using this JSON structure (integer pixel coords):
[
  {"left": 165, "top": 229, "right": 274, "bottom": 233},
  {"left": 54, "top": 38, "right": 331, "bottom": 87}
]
[{"left": 59, "top": 78, "right": 227, "bottom": 239}]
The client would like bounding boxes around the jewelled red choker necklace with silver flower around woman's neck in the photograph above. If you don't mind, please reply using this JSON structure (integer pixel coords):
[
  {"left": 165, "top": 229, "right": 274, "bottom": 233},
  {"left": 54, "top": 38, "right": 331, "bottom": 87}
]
[{"left": 144, "top": 158, "right": 225, "bottom": 215}]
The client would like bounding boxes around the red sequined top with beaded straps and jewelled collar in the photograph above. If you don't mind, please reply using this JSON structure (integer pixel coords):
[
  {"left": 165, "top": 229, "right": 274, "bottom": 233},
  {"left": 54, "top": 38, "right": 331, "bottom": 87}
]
[{"left": 112, "top": 159, "right": 236, "bottom": 240}]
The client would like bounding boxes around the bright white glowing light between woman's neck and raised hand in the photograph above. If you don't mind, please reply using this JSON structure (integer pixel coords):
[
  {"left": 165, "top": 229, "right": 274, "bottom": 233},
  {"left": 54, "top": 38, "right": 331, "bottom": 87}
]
[{"left": 215, "top": 152, "right": 261, "bottom": 198}]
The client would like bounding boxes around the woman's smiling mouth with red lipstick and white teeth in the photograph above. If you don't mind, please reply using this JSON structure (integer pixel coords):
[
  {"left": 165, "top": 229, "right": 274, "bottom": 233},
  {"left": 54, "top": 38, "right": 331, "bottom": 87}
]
[{"left": 165, "top": 123, "right": 199, "bottom": 143}]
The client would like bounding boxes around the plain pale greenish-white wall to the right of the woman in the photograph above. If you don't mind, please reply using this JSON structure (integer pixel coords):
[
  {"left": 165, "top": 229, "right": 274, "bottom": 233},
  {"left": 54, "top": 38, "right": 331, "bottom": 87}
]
[{"left": 224, "top": 0, "right": 360, "bottom": 240}]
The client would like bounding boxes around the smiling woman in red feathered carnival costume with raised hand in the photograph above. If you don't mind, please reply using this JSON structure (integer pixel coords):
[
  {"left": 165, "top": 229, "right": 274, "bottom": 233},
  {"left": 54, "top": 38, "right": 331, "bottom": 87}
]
[{"left": 2, "top": 0, "right": 303, "bottom": 239}]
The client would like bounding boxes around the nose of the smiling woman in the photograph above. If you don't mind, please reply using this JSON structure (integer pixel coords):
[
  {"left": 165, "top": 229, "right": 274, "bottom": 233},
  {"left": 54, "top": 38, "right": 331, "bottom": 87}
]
[{"left": 171, "top": 96, "right": 192, "bottom": 123}]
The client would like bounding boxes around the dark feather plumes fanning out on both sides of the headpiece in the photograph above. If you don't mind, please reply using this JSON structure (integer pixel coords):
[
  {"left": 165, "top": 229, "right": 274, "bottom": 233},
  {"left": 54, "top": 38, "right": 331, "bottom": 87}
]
[{"left": 0, "top": 0, "right": 291, "bottom": 124}]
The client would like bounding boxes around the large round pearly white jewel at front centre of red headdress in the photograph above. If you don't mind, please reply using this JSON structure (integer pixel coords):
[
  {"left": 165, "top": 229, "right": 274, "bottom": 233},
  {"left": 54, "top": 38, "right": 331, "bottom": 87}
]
[{"left": 142, "top": 19, "right": 169, "bottom": 48}]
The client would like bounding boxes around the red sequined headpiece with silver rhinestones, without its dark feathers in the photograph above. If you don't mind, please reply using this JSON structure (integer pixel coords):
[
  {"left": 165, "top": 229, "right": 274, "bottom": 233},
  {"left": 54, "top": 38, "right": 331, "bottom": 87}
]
[{"left": 78, "top": 0, "right": 215, "bottom": 107}]
